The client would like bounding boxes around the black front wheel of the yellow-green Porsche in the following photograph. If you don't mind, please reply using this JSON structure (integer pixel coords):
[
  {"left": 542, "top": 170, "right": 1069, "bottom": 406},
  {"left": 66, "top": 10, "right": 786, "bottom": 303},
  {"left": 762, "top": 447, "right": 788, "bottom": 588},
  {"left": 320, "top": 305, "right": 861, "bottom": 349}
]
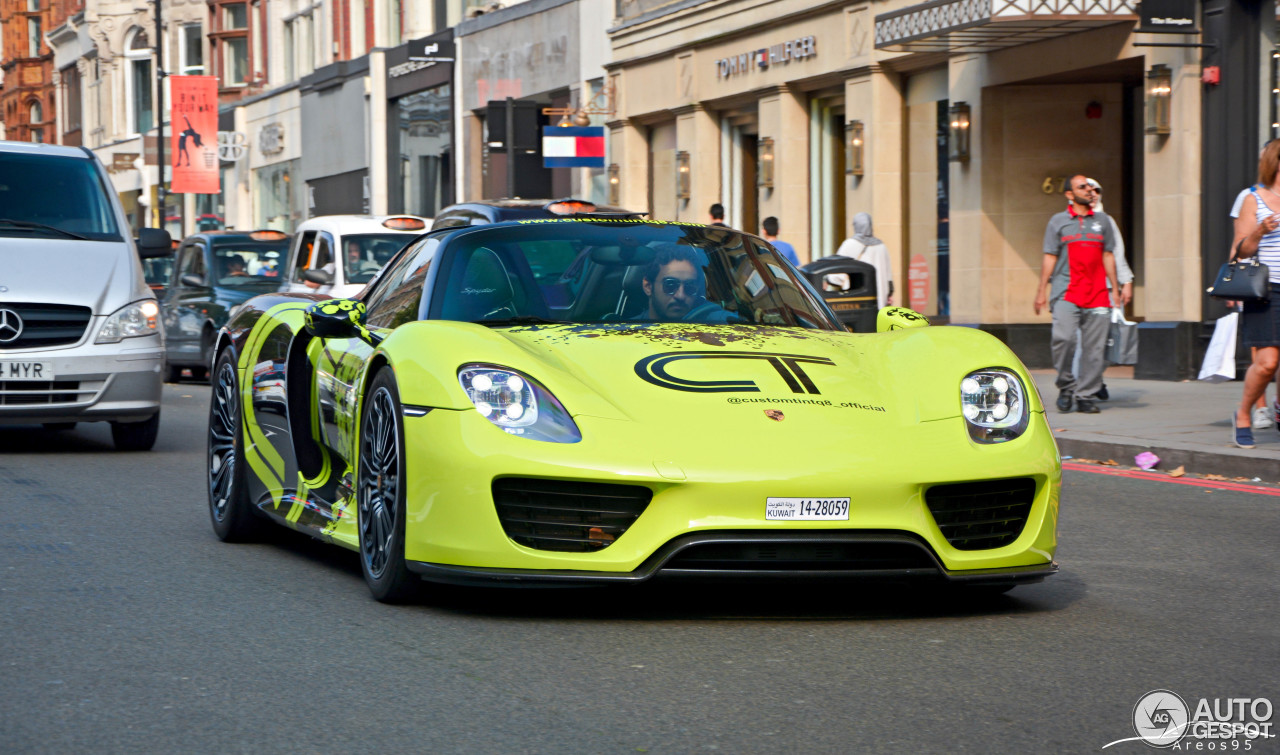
[{"left": 356, "top": 369, "right": 421, "bottom": 603}]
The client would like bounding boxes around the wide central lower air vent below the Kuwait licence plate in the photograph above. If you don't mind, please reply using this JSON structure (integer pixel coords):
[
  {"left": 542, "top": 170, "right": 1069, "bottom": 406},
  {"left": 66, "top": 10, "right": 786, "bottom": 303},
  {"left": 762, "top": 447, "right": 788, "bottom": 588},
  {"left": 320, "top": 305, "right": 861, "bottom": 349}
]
[{"left": 663, "top": 541, "right": 937, "bottom": 572}]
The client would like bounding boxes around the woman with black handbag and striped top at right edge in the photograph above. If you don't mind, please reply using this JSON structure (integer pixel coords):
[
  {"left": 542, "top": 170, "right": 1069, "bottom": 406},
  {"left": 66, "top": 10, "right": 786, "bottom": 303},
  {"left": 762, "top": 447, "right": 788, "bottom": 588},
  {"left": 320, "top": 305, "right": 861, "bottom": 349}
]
[{"left": 1233, "top": 139, "right": 1280, "bottom": 448}]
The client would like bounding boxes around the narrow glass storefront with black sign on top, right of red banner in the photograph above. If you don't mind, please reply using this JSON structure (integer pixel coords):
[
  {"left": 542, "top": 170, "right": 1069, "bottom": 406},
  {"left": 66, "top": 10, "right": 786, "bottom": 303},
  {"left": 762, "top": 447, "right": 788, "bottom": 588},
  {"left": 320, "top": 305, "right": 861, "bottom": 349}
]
[{"left": 385, "top": 29, "right": 457, "bottom": 218}]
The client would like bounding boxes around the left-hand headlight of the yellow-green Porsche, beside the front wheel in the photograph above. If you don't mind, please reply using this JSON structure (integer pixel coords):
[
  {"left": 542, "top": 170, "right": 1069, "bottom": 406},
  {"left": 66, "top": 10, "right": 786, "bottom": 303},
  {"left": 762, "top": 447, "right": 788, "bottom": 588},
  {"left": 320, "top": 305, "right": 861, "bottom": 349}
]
[{"left": 458, "top": 365, "right": 582, "bottom": 443}]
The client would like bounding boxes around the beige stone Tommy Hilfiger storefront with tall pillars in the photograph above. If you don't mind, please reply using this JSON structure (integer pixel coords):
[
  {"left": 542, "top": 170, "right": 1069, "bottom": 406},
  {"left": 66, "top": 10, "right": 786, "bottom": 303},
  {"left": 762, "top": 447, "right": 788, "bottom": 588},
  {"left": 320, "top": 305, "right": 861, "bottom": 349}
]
[{"left": 609, "top": 3, "right": 852, "bottom": 261}]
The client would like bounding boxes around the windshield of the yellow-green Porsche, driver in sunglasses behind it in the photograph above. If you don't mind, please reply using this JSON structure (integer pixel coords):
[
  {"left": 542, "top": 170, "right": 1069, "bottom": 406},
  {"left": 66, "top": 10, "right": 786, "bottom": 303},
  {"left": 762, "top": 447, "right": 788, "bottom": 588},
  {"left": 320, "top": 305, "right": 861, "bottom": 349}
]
[{"left": 429, "top": 219, "right": 844, "bottom": 330}]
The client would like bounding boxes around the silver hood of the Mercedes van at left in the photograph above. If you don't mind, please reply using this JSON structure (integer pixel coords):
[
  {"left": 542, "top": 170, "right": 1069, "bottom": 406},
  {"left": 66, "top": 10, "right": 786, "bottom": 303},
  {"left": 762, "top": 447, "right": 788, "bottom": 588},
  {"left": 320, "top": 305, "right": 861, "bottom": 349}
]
[{"left": 0, "top": 237, "right": 155, "bottom": 315}]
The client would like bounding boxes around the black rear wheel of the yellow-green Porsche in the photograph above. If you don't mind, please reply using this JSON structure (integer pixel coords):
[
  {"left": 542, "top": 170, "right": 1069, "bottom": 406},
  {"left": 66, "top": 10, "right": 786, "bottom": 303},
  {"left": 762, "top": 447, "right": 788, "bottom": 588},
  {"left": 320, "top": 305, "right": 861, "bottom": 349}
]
[{"left": 206, "top": 349, "right": 261, "bottom": 543}]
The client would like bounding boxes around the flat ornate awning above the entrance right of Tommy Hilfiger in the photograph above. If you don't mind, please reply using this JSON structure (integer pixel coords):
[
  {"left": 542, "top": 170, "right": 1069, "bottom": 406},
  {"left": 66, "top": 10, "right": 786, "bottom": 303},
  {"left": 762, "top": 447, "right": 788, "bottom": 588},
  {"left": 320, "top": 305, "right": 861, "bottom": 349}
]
[{"left": 876, "top": 0, "right": 1138, "bottom": 52}]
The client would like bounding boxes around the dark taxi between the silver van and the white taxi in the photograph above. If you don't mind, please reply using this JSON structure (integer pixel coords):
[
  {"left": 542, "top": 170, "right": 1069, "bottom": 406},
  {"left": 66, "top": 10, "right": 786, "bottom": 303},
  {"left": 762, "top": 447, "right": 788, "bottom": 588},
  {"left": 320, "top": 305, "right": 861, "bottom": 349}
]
[{"left": 160, "top": 230, "right": 289, "bottom": 383}]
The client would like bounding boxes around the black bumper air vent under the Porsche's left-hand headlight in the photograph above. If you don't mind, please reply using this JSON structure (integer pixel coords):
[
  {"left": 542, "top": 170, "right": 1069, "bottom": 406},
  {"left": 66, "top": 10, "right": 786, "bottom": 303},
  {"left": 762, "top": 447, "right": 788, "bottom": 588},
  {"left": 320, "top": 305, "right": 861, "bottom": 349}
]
[{"left": 493, "top": 477, "right": 653, "bottom": 553}]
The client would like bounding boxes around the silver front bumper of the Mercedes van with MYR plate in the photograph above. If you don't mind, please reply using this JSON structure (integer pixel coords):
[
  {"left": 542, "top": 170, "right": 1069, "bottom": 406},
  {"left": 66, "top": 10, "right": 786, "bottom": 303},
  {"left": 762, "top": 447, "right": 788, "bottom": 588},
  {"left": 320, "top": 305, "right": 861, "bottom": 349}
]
[{"left": 0, "top": 332, "right": 164, "bottom": 425}]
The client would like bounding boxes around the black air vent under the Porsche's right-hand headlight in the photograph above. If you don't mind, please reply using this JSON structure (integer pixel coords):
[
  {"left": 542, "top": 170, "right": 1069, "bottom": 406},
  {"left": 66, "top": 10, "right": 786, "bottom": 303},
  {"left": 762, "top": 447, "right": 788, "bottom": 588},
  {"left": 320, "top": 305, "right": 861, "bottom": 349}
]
[{"left": 924, "top": 477, "right": 1036, "bottom": 550}]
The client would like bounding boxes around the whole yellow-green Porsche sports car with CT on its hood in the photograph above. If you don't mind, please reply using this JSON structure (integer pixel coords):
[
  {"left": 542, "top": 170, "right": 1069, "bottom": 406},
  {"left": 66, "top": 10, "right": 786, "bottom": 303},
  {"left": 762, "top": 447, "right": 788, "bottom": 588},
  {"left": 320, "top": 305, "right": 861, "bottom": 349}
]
[{"left": 207, "top": 215, "right": 1061, "bottom": 601}]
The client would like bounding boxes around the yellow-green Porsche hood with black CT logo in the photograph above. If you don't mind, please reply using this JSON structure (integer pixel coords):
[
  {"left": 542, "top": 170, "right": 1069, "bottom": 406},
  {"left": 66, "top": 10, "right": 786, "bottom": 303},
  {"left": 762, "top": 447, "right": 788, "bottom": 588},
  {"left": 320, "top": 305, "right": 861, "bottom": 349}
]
[{"left": 388, "top": 321, "right": 1042, "bottom": 432}]
